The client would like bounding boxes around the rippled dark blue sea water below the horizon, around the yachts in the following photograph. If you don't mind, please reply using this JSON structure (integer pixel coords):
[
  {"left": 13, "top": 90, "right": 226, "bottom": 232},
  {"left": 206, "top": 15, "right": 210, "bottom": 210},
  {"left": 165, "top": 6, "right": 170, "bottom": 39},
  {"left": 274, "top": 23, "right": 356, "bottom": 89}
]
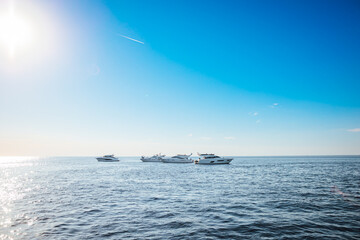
[{"left": 0, "top": 157, "right": 360, "bottom": 239}]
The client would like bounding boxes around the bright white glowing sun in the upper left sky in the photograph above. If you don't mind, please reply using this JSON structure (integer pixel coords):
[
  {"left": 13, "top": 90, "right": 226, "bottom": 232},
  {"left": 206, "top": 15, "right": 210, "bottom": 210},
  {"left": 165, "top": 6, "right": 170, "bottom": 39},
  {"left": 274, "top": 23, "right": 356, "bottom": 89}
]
[{"left": 0, "top": 4, "right": 32, "bottom": 57}]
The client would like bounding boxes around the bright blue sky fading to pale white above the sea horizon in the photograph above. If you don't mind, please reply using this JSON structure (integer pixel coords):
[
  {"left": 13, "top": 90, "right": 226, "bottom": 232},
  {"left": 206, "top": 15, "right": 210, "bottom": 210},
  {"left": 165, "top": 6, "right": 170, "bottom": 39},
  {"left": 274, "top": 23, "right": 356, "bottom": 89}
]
[{"left": 0, "top": 0, "right": 360, "bottom": 156}]
